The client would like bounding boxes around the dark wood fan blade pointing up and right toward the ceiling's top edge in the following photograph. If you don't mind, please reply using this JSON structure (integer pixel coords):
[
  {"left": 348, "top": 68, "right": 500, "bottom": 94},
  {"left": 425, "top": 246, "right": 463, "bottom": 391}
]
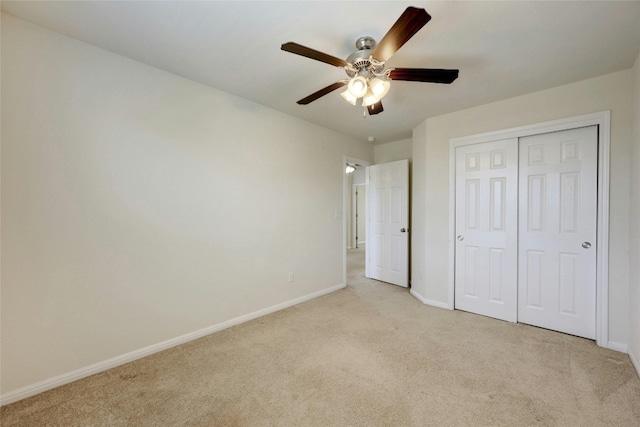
[{"left": 371, "top": 7, "right": 431, "bottom": 61}]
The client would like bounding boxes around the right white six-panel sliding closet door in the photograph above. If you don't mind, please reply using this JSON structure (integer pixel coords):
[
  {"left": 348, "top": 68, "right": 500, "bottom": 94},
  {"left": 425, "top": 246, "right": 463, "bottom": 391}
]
[{"left": 518, "top": 126, "right": 598, "bottom": 339}]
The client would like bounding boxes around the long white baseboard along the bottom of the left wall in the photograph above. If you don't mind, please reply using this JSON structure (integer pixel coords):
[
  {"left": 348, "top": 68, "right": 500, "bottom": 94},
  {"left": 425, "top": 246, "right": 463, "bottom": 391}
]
[{"left": 0, "top": 283, "right": 346, "bottom": 406}]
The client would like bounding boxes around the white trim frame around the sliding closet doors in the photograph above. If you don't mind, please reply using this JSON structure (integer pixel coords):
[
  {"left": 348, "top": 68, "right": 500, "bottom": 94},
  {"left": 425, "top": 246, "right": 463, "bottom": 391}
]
[{"left": 447, "top": 110, "right": 611, "bottom": 348}]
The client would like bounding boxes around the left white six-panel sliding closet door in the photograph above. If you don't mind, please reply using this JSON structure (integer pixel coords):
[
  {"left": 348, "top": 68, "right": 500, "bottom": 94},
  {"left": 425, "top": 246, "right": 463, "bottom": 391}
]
[{"left": 455, "top": 139, "right": 518, "bottom": 322}]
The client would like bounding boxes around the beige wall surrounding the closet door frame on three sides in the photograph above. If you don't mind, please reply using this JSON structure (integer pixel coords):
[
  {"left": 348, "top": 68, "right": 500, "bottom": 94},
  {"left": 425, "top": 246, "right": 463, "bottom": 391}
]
[{"left": 412, "top": 70, "right": 632, "bottom": 345}]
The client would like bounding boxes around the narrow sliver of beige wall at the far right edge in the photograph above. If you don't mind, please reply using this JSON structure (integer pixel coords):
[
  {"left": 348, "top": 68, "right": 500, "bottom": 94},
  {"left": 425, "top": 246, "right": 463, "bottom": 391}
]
[{"left": 629, "top": 54, "right": 640, "bottom": 374}]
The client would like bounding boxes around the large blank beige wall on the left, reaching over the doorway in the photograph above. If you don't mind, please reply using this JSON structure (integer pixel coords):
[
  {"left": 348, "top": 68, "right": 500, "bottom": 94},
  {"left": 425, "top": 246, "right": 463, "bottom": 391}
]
[{"left": 1, "top": 15, "right": 373, "bottom": 396}]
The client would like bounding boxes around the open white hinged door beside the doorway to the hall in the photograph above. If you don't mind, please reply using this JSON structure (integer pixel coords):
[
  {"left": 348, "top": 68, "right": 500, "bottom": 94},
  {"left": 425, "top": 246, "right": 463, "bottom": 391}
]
[{"left": 366, "top": 160, "right": 409, "bottom": 288}]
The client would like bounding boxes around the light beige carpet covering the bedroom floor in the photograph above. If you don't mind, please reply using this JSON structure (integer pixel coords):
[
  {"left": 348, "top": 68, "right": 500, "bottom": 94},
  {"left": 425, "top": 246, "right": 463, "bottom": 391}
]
[{"left": 0, "top": 249, "right": 640, "bottom": 427}]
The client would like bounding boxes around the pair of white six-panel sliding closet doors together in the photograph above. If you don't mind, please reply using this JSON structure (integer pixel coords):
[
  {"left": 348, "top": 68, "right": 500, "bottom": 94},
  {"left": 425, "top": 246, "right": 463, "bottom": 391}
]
[{"left": 454, "top": 126, "right": 598, "bottom": 339}]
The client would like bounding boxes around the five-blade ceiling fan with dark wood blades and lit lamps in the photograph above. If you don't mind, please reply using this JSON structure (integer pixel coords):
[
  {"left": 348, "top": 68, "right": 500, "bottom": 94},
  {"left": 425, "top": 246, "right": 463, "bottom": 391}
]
[{"left": 281, "top": 7, "right": 459, "bottom": 116}]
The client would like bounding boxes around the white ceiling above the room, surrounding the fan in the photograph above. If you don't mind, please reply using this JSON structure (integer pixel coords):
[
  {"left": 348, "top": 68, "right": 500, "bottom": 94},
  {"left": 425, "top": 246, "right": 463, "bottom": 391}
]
[{"left": 2, "top": 1, "right": 640, "bottom": 143}]
